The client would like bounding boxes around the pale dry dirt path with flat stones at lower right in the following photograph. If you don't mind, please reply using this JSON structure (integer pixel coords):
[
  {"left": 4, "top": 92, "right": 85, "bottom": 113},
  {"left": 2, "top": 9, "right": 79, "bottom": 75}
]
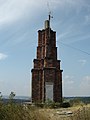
[{"left": 40, "top": 105, "right": 90, "bottom": 120}]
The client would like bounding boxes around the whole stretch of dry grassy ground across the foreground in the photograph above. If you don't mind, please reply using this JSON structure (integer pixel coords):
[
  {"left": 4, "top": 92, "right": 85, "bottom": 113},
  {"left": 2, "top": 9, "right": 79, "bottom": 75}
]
[{"left": 0, "top": 102, "right": 90, "bottom": 120}]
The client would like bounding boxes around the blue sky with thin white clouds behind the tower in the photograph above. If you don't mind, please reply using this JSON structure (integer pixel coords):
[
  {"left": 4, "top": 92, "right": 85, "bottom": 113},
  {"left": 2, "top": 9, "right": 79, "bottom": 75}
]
[{"left": 0, "top": 0, "right": 90, "bottom": 96}]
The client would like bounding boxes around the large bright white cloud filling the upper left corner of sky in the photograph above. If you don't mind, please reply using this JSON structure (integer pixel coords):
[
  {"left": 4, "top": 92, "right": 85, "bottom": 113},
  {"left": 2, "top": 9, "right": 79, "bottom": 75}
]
[{"left": 0, "top": 0, "right": 43, "bottom": 25}]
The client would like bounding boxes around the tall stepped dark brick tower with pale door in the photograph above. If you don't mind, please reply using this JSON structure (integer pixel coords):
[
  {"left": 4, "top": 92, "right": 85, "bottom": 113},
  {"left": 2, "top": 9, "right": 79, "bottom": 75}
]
[{"left": 31, "top": 15, "right": 63, "bottom": 102}]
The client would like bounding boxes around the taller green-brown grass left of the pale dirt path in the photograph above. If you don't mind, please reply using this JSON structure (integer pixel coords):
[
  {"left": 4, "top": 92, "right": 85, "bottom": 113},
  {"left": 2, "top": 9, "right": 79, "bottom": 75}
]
[{"left": 0, "top": 103, "right": 49, "bottom": 120}]
